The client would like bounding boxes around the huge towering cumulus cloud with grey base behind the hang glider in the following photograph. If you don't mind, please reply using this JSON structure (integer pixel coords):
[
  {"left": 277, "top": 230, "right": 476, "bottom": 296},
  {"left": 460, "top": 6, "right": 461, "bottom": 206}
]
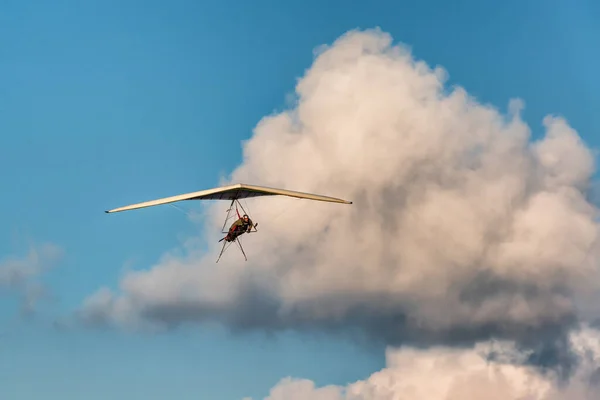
[{"left": 80, "top": 30, "right": 599, "bottom": 372}]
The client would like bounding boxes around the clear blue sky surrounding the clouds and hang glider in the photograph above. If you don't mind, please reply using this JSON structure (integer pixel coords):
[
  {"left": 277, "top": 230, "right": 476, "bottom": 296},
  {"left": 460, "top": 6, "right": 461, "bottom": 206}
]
[{"left": 0, "top": 0, "right": 600, "bottom": 400}]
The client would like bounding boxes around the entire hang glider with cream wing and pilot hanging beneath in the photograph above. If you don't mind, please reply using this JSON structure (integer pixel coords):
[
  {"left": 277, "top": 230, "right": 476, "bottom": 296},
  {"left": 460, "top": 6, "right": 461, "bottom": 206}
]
[{"left": 105, "top": 183, "right": 352, "bottom": 262}]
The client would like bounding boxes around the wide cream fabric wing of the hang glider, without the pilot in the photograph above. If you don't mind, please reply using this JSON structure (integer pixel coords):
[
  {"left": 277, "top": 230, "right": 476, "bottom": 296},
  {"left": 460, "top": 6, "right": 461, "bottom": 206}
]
[{"left": 105, "top": 183, "right": 352, "bottom": 213}]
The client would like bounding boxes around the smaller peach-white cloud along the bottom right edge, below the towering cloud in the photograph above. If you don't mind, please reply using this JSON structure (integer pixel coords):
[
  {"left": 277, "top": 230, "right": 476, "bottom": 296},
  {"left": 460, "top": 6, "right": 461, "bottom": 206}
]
[{"left": 256, "top": 329, "right": 600, "bottom": 400}]
